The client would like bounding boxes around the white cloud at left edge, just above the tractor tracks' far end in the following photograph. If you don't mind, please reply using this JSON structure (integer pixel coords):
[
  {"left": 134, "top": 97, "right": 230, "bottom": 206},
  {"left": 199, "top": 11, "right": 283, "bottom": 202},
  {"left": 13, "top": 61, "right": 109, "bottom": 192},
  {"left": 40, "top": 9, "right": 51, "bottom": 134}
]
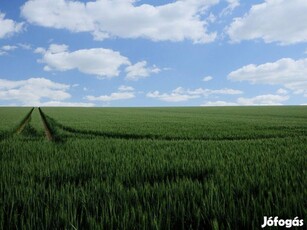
[{"left": 0, "top": 78, "right": 71, "bottom": 105}]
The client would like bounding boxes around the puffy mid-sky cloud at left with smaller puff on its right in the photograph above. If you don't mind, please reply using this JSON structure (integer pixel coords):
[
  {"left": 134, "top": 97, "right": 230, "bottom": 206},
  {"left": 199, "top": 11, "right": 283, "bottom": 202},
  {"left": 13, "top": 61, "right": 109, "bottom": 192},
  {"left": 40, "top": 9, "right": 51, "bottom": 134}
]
[{"left": 34, "top": 44, "right": 161, "bottom": 81}]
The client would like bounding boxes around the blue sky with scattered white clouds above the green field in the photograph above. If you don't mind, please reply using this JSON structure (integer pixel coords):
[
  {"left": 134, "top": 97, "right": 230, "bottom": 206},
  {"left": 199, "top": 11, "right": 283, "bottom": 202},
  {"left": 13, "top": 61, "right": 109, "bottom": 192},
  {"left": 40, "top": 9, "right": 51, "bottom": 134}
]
[{"left": 0, "top": 0, "right": 307, "bottom": 107}]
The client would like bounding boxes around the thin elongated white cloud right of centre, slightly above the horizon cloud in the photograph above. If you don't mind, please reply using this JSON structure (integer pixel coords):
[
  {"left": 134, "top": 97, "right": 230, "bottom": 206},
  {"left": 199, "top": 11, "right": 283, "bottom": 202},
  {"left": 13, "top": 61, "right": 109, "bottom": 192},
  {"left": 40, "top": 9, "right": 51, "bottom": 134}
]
[{"left": 146, "top": 87, "right": 242, "bottom": 102}]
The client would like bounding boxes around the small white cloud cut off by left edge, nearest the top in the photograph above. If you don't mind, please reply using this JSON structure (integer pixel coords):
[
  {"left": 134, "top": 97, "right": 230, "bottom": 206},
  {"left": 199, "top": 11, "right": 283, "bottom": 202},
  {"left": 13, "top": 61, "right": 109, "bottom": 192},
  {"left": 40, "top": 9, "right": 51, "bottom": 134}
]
[{"left": 0, "top": 12, "right": 23, "bottom": 39}]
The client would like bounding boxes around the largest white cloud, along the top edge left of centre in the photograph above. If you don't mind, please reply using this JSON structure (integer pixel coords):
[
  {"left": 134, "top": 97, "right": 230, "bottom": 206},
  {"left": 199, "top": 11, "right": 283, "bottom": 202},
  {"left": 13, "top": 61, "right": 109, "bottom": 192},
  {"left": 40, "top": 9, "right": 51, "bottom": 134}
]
[{"left": 21, "top": 0, "right": 219, "bottom": 43}]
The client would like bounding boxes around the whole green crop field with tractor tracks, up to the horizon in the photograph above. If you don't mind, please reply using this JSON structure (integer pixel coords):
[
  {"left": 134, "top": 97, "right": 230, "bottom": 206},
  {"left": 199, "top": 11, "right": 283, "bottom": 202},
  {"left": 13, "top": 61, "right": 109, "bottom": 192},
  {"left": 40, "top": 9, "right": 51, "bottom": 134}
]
[{"left": 0, "top": 106, "right": 307, "bottom": 229}]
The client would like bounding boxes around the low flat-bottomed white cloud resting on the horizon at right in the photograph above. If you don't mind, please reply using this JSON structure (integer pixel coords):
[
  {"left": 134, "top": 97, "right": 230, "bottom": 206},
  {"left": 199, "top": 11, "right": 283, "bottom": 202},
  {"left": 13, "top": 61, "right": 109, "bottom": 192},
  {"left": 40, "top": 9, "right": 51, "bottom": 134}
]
[{"left": 201, "top": 94, "right": 289, "bottom": 106}]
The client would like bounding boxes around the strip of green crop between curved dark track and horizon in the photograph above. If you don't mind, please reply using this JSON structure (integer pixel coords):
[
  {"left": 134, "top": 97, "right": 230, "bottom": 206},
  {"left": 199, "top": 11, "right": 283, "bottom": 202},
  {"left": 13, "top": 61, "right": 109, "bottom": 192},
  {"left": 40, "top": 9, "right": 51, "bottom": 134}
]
[{"left": 44, "top": 107, "right": 307, "bottom": 140}]
